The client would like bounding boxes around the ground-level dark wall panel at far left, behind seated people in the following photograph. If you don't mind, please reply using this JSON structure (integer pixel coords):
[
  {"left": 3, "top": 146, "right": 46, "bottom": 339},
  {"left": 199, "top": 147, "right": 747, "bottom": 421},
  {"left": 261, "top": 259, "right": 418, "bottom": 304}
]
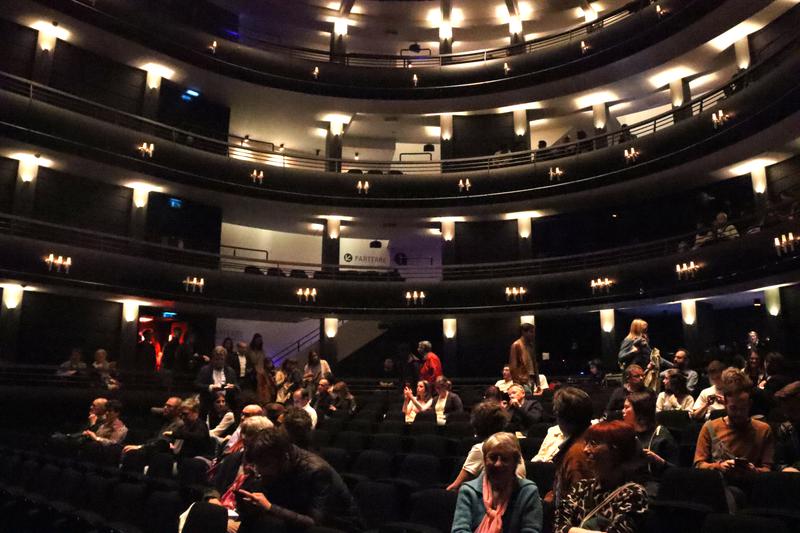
[{"left": 18, "top": 292, "right": 122, "bottom": 364}]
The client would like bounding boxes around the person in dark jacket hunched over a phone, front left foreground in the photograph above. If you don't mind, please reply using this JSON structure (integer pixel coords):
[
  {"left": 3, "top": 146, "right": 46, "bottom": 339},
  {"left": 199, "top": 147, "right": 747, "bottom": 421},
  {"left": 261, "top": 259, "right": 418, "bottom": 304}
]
[{"left": 238, "top": 429, "right": 363, "bottom": 532}]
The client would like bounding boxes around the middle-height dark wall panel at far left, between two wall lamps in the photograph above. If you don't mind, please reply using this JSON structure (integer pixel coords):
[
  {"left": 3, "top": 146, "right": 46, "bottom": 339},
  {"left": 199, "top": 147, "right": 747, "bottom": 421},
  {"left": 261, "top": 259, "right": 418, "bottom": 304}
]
[{"left": 35, "top": 168, "right": 133, "bottom": 235}]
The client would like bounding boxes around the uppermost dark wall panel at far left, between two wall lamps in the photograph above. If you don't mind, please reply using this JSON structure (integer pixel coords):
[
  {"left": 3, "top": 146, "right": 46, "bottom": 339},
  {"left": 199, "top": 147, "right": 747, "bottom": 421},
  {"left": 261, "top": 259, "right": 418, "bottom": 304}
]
[{"left": 50, "top": 41, "right": 147, "bottom": 113}]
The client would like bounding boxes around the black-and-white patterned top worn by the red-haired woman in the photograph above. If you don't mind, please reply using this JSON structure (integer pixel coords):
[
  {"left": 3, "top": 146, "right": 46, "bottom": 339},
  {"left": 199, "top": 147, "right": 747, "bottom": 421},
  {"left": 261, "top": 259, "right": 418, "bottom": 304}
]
[{"left": 553, "top": 479, "right": 647, "bottom": 533}]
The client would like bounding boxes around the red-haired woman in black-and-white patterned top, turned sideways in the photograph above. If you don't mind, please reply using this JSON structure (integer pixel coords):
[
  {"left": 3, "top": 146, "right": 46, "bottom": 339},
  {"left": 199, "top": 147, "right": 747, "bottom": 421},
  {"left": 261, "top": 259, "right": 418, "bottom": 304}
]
[{"left": 553, "top": 420, "right": 647, "bottom": 533}]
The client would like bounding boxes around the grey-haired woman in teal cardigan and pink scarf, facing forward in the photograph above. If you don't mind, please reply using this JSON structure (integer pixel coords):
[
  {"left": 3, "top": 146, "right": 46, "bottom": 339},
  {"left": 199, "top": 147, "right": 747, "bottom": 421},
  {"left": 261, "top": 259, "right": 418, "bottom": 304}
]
[{"left": 451, "top": 433, "right": 542, "bottom": 533}]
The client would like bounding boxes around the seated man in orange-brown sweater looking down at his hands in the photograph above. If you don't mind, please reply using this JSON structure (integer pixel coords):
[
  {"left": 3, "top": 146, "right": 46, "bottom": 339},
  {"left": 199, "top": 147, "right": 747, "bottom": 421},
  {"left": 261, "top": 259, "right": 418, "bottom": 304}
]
[{"left": 694, "top": 368, "right": 775, "bottom": 475}]
